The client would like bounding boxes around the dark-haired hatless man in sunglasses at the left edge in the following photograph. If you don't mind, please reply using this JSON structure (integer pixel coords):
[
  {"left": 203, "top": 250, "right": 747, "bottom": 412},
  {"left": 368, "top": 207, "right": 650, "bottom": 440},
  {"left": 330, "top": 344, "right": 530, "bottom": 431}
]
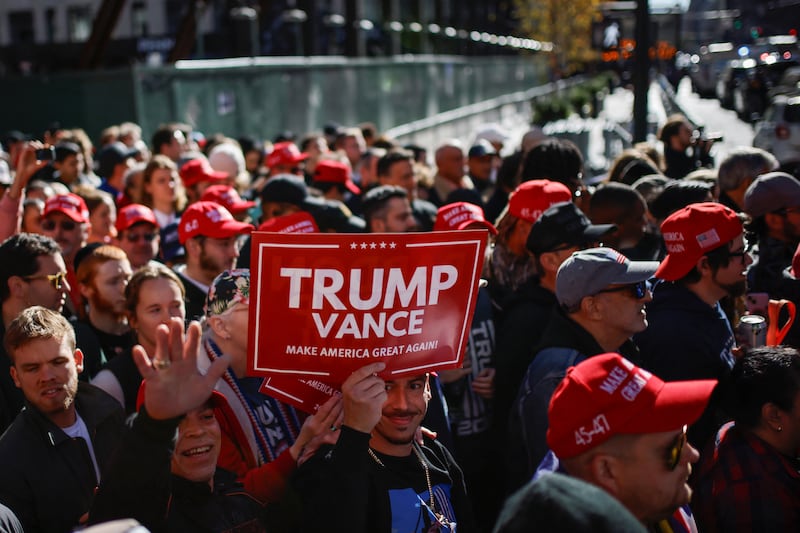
[{"left": 0, "top": 233, "right": 70, "bottom": 433}]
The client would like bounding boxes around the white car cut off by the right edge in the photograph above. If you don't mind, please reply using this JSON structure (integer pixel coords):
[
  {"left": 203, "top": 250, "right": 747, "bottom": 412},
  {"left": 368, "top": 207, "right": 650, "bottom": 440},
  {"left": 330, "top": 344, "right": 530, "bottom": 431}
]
[{"left": 753, "top": 91, "right": 800, "bottom": 167}]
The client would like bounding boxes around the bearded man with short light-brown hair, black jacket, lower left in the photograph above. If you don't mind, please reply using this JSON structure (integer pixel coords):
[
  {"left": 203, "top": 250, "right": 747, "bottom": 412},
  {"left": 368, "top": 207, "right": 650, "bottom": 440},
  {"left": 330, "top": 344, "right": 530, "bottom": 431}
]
[{"left": 0, "top": 306, "right": 124, "bottom": 532}]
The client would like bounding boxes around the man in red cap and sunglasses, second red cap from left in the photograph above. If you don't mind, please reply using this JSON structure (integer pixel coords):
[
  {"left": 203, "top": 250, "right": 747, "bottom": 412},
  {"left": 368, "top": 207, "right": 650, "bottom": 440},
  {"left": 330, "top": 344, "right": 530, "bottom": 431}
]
[{"left": 116, "top": 204, "right": 161, "bottom": 270}]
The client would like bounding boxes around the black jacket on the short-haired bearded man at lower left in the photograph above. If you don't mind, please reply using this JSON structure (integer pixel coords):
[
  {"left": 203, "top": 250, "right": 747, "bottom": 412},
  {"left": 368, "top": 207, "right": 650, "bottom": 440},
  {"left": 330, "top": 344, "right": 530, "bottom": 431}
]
[{"left": 0, "top": 383, "right": 124, "bottom": 533}]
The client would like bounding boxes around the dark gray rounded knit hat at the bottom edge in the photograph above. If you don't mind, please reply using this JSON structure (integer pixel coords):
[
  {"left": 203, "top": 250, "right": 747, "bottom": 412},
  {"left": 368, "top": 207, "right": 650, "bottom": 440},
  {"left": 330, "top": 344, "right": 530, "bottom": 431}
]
[{"left": 494, "top": 473, "right": 647, "bottom": 533}]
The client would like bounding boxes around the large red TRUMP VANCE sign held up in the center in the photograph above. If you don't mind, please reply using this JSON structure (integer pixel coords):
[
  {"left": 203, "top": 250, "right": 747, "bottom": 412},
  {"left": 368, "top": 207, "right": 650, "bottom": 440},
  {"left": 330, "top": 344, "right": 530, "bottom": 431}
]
[{"left": 248, "top": 230, "right": 487, "bottom": 384}]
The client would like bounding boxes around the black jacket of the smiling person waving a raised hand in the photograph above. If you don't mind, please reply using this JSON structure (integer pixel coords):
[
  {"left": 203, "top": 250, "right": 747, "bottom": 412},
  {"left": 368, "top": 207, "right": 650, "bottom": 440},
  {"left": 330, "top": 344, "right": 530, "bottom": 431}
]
[{"left": 89, "top": 409, "right": 266, "bottom": 533}]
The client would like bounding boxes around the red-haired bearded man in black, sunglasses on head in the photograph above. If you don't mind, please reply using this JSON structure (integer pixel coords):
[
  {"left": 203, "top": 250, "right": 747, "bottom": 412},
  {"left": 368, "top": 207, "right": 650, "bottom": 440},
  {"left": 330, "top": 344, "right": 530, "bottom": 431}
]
[{"left": 73, "top": 245, "right": 134, "bottom": 379}]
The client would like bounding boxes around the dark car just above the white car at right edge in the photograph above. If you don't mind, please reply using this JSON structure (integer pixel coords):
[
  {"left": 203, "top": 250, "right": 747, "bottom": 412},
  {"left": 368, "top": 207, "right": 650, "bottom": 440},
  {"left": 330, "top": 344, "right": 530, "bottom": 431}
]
[{"left": 732, "top": 55, "right": 800, "bottom": 122}]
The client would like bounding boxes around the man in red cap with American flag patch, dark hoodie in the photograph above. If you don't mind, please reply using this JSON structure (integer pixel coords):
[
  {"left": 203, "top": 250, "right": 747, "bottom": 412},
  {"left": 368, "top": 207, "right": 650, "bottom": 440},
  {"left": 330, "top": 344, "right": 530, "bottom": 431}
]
[{"left": 634, "top": 202, "right": 753, "bottom": 450}]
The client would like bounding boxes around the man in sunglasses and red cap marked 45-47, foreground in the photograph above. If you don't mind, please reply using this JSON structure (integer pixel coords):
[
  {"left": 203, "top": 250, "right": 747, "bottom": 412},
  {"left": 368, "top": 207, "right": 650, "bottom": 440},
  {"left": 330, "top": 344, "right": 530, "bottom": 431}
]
[{"left": 534, "top": 353, "right": 717, "bottom": 532}]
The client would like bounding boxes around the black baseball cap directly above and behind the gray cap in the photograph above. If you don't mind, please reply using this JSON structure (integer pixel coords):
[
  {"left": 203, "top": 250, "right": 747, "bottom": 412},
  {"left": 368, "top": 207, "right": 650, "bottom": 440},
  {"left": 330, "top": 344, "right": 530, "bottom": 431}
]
[{"left": 526, "top": 202, "right": 617, "bottom": 254}]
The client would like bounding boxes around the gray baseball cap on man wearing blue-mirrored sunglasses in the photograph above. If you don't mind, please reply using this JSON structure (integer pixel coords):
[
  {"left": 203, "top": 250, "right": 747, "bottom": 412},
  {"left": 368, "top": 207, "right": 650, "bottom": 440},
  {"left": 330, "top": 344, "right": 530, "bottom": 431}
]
[{"left": 556, "top": 248, "right": 658, "bottom": 308}]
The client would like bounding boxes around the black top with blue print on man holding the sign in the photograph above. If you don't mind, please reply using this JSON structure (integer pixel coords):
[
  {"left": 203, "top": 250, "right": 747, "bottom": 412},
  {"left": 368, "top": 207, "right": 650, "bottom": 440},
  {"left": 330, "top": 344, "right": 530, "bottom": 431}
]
[{"left": 295, "top": 426, "right": 476, "bottom": 533}]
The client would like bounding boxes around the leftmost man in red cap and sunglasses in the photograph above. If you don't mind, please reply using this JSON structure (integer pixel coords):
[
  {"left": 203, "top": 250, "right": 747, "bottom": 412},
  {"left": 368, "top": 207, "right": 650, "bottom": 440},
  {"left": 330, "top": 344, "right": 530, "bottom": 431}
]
[{"left": 42, "top": 193, "right": 91, "bottom": 315}]
